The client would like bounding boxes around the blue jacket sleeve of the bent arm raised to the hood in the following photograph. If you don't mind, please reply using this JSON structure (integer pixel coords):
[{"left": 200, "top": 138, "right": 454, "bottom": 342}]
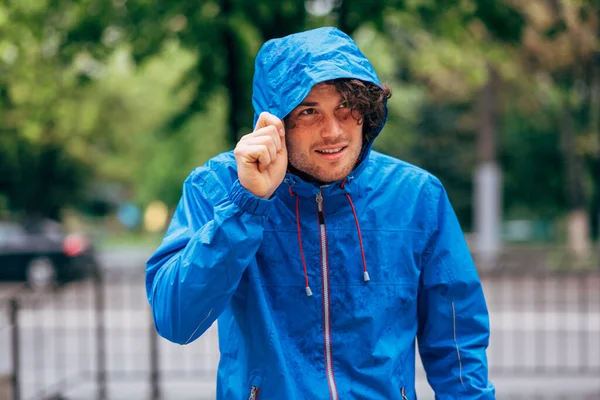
[{"left": 146, "top": 167, "right": 272, "bottom": 344}]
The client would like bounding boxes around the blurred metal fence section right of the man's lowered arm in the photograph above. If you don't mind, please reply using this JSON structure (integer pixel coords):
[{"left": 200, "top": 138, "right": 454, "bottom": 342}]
[{"left": 481, "top": 270, "right": 600, "bottom": 377}]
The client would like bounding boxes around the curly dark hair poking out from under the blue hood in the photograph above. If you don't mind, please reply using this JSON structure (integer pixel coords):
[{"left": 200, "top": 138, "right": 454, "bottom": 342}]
[{"left": 284, "top": 78, "right": 392, "bottom": 141}]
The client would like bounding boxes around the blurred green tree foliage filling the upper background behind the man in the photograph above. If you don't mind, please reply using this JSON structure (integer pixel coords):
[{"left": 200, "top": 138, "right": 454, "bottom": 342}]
[{"left": 0, "top": 0, "right": 600, "bottom": 239}]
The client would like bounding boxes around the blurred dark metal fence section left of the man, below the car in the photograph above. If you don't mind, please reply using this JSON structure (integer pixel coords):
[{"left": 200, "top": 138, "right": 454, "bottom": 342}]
[{"left": 0, "top": 276, "right": 218, "bottom": 400}]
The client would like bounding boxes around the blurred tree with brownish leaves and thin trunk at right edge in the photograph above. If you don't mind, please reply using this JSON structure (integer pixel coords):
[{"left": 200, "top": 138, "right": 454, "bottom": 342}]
[{"left": 510, "top": 0, "right": 600, "bottom": 255}]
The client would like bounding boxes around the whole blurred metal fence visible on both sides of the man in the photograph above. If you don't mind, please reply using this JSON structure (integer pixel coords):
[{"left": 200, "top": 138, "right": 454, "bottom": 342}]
[{"left": 0, "top": 268, "right": 600, "bottom": 400}]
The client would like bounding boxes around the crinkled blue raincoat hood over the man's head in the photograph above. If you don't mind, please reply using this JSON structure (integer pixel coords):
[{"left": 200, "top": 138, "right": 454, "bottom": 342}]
[{"left": 252, "top": 27, "right": 387, "bottom": 161}]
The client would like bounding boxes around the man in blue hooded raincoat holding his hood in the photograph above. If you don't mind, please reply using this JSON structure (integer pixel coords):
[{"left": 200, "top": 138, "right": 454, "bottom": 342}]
[{"left": 146, "top": 28, "right": 494, "bottom": 400}]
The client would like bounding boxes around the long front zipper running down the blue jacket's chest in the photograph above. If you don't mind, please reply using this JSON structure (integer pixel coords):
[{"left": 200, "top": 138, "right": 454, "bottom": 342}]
[{"left": 317, "top": 191, "right": 338, "bottom": 400}]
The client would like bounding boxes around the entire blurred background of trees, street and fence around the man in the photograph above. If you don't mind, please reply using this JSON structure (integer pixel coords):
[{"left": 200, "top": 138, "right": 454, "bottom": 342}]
[{"left": 0, "top": 0, "right": 600, "bottom": 400}]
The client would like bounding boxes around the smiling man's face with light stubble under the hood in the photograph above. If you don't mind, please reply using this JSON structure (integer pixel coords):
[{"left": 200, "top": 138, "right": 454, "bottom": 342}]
[{"left": 286, "top": 83, "right": 363, "bottom": 182}]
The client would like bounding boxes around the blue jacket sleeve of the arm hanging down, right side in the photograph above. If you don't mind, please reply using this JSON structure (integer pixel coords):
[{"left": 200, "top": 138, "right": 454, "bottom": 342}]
[{"left": 417, "top": 180, "right": 495, "bottom": 400}]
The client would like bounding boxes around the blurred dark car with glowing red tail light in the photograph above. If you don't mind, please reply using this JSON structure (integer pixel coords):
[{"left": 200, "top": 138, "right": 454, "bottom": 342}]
[{"left": 0, "top": 221, "right": 99, "bottom": 289}]
